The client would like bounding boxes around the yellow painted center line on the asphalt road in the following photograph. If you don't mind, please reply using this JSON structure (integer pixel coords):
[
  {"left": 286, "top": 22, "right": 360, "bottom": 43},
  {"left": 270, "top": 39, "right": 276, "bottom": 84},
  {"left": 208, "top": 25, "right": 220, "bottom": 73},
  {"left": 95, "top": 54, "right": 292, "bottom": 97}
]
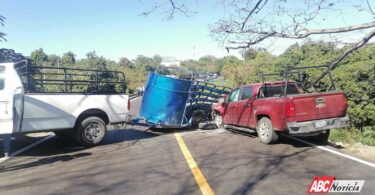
[{"left": 174, "top": 132, "right": 215, "bottom": 195}]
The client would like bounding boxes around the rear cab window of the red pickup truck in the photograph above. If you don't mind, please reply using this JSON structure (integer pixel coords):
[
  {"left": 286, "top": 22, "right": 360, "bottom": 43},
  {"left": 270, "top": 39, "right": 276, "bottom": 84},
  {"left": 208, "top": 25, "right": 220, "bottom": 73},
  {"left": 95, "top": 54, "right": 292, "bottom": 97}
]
[{"left": 258, "top": 84, "right": 298, "bottom": 98}]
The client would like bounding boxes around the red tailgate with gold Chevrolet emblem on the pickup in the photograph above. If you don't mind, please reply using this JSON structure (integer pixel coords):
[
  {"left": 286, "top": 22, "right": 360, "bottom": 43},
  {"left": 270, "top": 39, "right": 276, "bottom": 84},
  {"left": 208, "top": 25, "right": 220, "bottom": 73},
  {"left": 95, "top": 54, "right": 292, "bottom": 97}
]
[{"left": 292, "top": 92, "right": 348, "bottom": 122}]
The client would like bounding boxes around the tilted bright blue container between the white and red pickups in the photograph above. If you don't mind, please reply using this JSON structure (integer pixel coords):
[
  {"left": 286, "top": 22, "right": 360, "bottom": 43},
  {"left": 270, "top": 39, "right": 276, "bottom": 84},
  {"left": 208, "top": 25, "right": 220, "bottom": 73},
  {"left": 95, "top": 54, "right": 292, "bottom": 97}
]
[{"left": 139, "top": 73, "right": 192, "bottom": 127}]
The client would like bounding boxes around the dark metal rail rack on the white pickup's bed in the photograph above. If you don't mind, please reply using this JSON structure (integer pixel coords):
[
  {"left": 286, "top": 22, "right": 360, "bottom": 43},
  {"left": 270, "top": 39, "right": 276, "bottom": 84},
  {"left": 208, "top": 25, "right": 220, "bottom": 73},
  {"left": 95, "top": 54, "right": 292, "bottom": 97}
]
[{"left": 15, "top": 61, "right": 126, "bottom": 94}]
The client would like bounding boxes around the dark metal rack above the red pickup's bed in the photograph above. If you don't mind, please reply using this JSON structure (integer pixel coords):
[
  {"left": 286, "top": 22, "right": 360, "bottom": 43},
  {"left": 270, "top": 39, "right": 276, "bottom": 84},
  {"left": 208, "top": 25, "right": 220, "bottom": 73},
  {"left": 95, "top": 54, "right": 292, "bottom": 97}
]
[{"left": 261, "top": 65, "right": 336, "bottom": 96}]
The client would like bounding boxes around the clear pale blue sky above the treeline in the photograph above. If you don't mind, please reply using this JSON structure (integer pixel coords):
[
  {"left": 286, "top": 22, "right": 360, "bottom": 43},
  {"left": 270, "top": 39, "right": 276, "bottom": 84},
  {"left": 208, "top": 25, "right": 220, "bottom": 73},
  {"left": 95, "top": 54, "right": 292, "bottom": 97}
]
[{"left": 0, "top": 0, "right": 374, "bottom": 60}]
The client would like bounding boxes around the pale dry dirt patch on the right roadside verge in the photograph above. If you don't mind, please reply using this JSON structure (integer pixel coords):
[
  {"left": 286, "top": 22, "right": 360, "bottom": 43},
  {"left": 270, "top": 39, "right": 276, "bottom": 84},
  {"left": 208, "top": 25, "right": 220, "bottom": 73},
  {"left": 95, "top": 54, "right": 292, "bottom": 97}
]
[{"left": 330, "top": 142, "right": 375, "bottom": 163}]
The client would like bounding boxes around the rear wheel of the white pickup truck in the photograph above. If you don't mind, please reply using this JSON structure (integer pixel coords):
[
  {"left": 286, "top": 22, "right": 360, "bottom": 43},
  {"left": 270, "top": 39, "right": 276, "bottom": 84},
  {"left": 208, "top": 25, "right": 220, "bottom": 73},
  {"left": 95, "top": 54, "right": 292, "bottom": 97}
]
[{"left": 75, "top": 116, "right": 107, "bottom": 147}]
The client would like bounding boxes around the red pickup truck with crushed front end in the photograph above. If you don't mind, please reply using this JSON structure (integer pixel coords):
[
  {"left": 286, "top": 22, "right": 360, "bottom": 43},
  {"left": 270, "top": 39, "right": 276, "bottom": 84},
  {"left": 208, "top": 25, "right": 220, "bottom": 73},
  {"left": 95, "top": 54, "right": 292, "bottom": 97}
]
[{"left": 213, "top": 81, "right": 349, "bottom": 144}]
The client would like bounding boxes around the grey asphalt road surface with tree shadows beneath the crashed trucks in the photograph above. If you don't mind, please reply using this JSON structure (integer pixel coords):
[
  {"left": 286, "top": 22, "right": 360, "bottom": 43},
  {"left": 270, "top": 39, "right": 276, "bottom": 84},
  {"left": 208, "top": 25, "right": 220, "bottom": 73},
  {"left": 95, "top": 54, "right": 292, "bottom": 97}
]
[{"left": 0, "top": 99, "right": 375, "bottom": 194}]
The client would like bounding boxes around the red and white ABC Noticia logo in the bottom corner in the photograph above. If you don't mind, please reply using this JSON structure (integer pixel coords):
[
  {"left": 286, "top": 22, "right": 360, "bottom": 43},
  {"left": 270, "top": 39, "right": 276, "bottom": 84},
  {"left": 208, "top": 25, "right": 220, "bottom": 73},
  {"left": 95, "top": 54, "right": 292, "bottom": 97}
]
[{"left": 307, "top": 176, "right": 365, "bottom": 193}]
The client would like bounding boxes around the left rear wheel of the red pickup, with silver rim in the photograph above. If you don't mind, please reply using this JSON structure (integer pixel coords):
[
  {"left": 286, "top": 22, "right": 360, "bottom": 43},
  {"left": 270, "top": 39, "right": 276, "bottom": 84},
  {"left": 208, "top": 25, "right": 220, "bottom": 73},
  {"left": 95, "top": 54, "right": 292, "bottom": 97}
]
[{"left": 257, "top": 117, "right": 279, "bottom": 144}]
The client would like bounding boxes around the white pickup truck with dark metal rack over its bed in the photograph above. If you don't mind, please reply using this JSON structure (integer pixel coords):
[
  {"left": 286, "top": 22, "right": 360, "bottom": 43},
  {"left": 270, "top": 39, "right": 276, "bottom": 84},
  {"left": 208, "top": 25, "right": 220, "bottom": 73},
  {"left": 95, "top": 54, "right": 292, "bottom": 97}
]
[{"left": 0, "top": 62, "right": 130, "bottom": 146}]
